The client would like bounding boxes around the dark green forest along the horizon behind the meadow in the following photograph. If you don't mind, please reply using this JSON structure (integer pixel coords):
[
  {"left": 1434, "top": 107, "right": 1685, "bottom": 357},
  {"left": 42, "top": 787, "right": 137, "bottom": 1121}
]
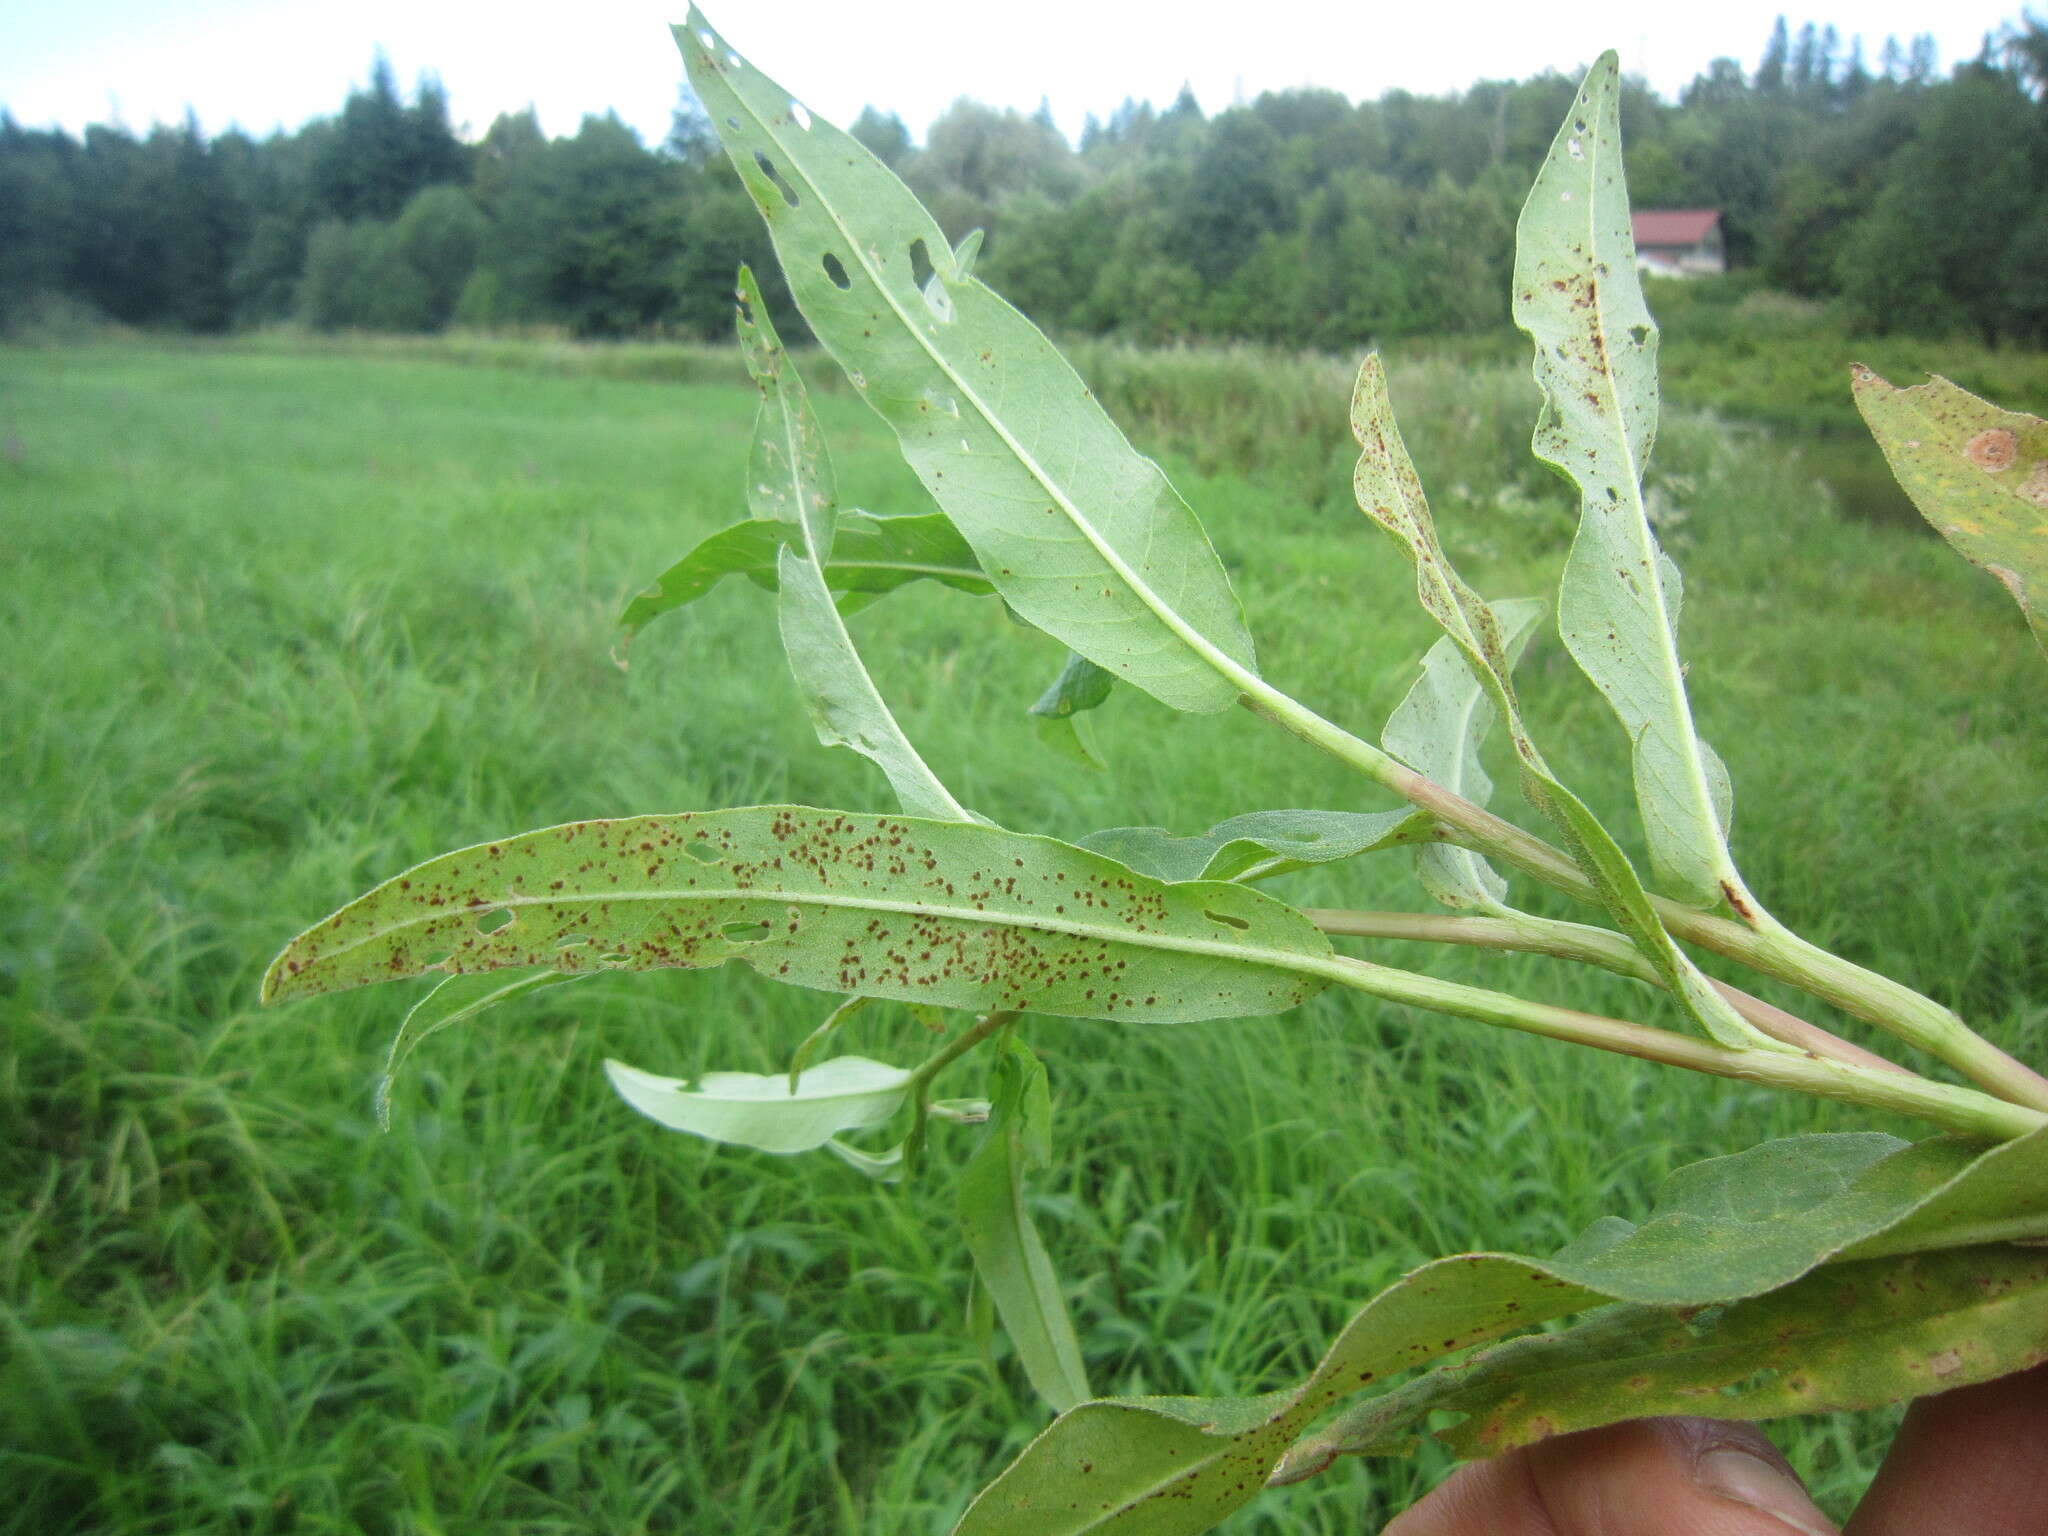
[{"left": 0, "top": 16, "right": 2048, "bottom": 348}]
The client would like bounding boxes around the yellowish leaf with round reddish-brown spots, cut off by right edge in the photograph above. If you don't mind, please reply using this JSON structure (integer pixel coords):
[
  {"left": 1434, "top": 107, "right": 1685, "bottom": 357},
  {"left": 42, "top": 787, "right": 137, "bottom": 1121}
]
[{"left": 1853, "top": 367, "right": 2048, "bottom": 663}]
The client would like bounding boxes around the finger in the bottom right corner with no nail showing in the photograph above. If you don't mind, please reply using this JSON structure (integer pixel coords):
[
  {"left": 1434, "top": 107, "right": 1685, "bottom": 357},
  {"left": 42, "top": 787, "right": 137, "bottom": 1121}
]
[{"left": 1849, "top": 1366, "right": 2048, "bottom": 1536}]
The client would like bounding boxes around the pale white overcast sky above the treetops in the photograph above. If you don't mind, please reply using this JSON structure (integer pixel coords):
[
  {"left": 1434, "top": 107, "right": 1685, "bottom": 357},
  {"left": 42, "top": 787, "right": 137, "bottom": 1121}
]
[{"left": 0, "top": 0, "right": 2019, "bottom": 143}]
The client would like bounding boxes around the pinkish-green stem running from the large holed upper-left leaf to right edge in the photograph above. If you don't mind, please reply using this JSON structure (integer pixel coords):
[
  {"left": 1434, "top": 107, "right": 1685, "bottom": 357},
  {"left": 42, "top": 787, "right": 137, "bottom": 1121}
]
[{"left": 1229, "top": 692, "right": 2048, "bottom": 1110}]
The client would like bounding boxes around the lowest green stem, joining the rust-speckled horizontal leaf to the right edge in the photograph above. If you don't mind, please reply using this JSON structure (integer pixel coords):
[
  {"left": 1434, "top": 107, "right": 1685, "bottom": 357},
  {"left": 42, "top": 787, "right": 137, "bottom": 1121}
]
[{"left": 1298, "top": 954, "right": 2048, "bottom": 1141}]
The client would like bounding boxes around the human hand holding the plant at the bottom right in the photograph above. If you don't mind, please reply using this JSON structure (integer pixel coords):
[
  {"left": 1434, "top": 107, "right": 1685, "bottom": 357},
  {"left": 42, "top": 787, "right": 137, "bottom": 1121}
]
[{"left": 1382, "top": 1366, "right": 2048, "bottom": 1536}]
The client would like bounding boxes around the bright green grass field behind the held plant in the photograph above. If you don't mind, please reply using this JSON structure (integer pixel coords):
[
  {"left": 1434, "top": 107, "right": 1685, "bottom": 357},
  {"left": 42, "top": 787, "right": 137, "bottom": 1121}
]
[{"left": 0, "top": 331, "right": 2048, "bottom": 1536}]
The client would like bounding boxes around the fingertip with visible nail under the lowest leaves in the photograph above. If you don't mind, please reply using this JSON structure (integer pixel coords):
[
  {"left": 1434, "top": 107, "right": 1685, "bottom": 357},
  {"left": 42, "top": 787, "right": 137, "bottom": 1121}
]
[{"left": 1384, "top": 1419, "right": 1835, "bottom": 1536}]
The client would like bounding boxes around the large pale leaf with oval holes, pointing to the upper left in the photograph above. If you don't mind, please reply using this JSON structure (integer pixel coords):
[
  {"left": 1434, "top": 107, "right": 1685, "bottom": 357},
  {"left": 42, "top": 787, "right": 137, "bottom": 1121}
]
[{"left": 676, "top": 10, "right": 1253, "bottom": 711}]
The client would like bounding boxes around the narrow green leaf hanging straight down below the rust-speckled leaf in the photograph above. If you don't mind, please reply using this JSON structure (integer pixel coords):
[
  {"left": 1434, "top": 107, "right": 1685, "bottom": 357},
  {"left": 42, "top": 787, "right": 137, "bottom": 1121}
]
[{"left": 958, "top": 1040, "right": 1087, "bottom": 1413}]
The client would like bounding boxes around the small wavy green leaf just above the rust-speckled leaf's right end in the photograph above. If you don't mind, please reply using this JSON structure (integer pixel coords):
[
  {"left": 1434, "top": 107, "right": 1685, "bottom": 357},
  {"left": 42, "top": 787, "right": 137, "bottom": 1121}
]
[{"left": 1081, "top": 811, "right": 1432, "bottom": 881}]
